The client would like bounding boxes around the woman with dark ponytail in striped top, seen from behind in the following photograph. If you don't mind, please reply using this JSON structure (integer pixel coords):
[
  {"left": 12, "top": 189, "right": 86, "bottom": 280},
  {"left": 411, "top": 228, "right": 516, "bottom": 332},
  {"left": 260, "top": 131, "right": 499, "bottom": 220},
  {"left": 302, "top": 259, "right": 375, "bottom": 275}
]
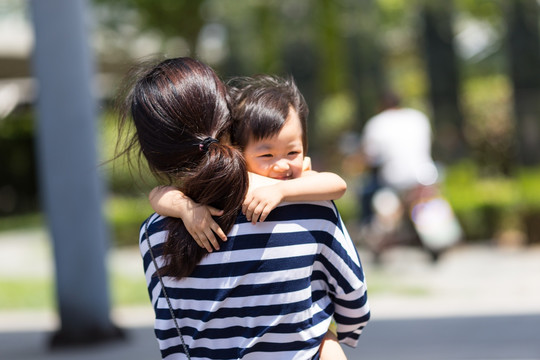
[{"left": 118, "top": 58, "right": 369, "bottom": 359}]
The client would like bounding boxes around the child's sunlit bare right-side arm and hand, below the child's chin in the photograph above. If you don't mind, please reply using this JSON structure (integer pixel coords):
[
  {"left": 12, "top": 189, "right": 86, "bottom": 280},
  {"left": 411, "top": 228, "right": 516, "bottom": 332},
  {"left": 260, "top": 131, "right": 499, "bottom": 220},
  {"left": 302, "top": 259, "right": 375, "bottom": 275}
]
[{"left": 242, "top": 170, "right": 347, "bottom": 223}]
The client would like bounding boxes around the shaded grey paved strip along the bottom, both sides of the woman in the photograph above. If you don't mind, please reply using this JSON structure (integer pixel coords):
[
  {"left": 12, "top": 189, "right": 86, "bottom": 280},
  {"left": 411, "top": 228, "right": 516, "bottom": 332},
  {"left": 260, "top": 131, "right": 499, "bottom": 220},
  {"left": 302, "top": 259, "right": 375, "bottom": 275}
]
[{"left": 4, "top": 314, "right": 540, "bottom": 360}]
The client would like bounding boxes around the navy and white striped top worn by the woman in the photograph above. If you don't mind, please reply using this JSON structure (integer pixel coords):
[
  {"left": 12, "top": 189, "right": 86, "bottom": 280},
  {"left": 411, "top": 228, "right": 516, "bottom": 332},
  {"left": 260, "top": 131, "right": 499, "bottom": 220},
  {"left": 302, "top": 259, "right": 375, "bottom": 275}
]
[{"left": 140, "top": 202, "right": 370, "bottom": 360}]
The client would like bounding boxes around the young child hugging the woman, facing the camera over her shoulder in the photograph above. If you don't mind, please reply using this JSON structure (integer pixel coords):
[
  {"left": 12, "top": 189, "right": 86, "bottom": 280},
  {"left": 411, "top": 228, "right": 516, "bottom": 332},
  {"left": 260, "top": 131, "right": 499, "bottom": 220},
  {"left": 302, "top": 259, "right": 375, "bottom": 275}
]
[{"left": 149, "top": 75, "right": 347, "bottom": 360}]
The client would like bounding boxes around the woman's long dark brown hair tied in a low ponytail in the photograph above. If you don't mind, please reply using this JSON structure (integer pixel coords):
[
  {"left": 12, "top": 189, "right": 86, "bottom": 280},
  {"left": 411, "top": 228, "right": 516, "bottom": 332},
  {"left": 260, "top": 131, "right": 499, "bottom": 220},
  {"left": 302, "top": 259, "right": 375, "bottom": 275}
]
[{"left": 120, "top": 58, "right": 248, "bottom": 278}]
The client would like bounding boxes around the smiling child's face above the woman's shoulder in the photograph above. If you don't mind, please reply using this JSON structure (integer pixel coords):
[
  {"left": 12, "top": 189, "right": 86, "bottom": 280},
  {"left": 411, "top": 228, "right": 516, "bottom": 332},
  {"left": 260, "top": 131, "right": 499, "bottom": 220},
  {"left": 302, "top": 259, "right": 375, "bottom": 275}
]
[{"left": 244, "top": 108, "right": 304, "bottom": 180}]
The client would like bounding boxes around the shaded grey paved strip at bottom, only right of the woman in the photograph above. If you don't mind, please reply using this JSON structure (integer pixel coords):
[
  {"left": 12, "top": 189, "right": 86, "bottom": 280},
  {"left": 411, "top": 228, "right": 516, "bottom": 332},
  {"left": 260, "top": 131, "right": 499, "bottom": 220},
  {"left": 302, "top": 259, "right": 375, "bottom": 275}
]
[{"left": 345, "top": 314, "right": 540, "bottom": 360}]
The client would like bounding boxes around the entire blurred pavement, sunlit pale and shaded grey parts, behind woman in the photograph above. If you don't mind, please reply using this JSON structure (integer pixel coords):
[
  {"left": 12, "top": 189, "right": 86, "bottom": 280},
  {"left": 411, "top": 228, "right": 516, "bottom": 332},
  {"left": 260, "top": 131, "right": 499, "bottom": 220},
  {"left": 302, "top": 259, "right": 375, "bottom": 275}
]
[{"left": 0, "top": 231, "right": 540, "bottom": 360}]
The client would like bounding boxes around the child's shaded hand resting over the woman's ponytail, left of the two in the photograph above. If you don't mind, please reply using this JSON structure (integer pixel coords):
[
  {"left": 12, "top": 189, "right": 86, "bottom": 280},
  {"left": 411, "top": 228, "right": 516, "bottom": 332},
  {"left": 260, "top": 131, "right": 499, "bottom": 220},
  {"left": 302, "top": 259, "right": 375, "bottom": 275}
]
[{"left": 182, "top": 202, "right": 227, "bottom": 252}]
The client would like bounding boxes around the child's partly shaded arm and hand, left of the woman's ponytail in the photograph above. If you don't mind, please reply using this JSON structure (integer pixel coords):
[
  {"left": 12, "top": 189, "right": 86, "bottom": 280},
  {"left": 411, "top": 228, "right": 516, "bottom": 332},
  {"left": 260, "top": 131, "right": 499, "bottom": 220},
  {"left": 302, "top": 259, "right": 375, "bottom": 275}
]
[{"left": 148, "top": 186, "right": 227, "bottom": 252}]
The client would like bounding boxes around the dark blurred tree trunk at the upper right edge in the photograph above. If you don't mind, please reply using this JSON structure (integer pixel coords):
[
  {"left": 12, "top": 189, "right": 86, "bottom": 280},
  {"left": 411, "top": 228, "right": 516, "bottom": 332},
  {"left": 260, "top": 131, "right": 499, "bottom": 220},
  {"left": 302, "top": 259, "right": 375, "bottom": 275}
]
[{"left": 504, "top": 0, "right": 540, "bottom": 166}]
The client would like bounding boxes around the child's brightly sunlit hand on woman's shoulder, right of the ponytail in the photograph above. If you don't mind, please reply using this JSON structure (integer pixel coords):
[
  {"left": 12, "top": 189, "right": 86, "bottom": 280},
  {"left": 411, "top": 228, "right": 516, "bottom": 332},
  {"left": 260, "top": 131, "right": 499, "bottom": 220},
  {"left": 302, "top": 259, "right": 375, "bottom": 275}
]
[{"left": 242, "top": 184, "right": 283, "bottom": 224}]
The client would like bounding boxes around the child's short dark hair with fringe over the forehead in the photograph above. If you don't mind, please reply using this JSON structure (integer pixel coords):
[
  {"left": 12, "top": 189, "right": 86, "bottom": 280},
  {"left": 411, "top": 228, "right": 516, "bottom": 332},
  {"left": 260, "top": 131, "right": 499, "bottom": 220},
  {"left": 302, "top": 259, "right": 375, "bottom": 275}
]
[{"left": 229, "top": 75, "right": 309, "bottom": 153}]
